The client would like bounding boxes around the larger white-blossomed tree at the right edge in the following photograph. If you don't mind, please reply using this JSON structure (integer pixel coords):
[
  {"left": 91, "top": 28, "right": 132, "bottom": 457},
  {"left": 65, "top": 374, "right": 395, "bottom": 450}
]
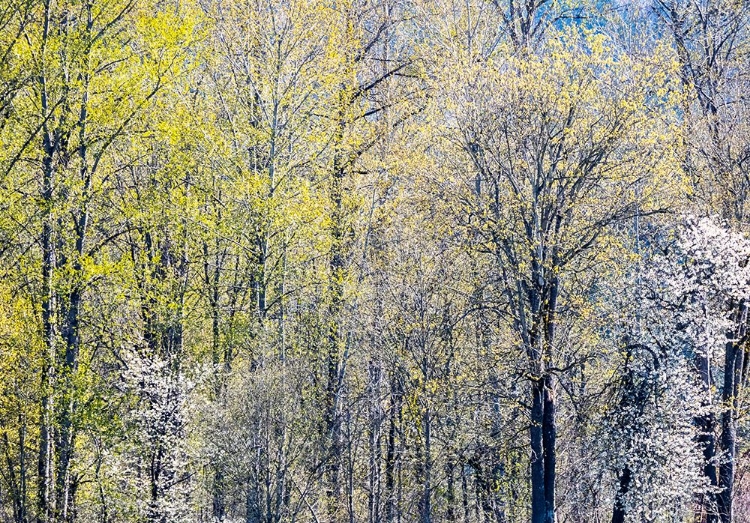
[{"left": 610, "top": 217, "right": 750, "bottom": 522}]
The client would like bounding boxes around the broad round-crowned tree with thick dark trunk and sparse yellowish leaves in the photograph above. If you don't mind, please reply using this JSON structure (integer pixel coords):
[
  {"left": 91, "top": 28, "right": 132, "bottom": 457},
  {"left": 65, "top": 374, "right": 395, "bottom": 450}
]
[{"left": 428, "top": 24, "right": 680, "bottom": 522}]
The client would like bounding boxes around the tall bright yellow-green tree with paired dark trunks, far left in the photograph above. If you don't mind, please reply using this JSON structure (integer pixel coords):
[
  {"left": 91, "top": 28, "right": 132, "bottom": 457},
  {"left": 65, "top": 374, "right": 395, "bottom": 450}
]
[{"left": 7, "top": 2, "right": 195, "bottom": 521}]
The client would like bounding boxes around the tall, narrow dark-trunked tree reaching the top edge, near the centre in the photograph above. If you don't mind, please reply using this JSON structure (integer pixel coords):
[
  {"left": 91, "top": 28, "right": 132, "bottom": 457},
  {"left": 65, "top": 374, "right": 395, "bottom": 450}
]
[{"left": 310, "top": 1, "right": 413, "bottom": 520}]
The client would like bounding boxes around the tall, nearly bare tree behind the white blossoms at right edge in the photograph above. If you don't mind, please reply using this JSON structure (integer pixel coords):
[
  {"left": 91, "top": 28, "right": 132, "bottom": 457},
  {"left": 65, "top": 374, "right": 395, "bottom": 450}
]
[{"left": 654, "top": 0, "right": 750, "bottom": 522}]
